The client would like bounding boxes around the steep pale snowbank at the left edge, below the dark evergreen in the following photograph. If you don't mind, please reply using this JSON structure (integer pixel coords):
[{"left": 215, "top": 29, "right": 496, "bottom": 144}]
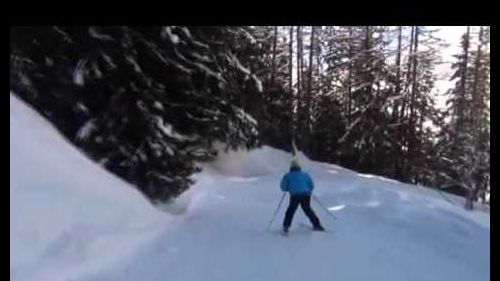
[{"left": 10, "top": 93, "right": 166, "bottom": 281}]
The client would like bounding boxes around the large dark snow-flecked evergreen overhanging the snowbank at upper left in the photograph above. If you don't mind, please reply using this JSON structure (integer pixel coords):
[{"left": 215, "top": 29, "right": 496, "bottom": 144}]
[{"left": 11, "top": 26, "right": 261, "bottom": 200}]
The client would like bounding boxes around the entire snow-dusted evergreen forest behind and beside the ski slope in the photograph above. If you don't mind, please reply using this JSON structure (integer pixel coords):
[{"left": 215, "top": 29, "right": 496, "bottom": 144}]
[{"left": 10, "top": 26, "right": 490, "bottom": 209}]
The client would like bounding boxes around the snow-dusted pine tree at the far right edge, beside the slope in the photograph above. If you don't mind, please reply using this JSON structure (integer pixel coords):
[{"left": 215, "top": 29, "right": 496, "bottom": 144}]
[{"left": 438, "top": 27, "right": 490, "bottom": 209}]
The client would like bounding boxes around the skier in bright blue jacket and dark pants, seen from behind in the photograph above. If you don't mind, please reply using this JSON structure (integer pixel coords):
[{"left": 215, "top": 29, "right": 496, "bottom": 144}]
[{"left": 281, "top": 159, "right": 325, "bottom": 233}]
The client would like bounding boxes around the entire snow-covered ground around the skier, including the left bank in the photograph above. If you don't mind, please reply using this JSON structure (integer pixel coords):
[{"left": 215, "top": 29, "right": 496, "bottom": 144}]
[{"left": 10, "top": 95, "right": 490, "bottom": 281}]
